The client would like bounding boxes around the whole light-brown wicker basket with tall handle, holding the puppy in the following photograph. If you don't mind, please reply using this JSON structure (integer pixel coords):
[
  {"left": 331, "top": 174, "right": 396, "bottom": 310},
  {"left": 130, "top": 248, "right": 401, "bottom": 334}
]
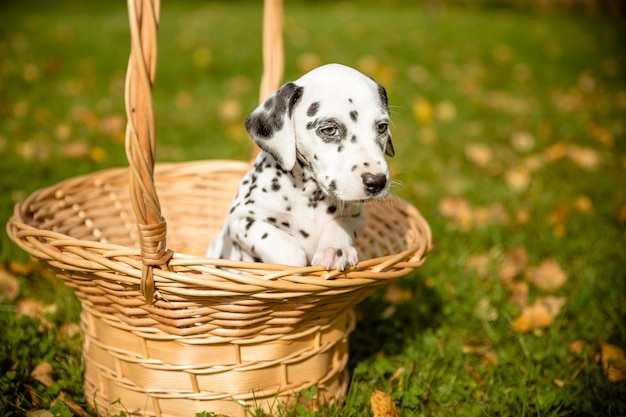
[{"left": 7, "top": 0, "right": 430, "bottom": 416}]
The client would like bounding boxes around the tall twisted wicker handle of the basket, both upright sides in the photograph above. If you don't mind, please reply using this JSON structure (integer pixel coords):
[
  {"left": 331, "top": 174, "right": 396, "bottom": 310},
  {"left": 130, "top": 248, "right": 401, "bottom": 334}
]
[{"left": 124, "top": 0, "right": 284, "bottom": 304}]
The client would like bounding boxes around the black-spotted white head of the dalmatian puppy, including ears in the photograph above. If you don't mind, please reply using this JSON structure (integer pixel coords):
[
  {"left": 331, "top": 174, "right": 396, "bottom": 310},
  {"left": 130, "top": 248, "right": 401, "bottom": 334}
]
[{"left": 246, "top": 64, "right": 394, "bottom": 201}]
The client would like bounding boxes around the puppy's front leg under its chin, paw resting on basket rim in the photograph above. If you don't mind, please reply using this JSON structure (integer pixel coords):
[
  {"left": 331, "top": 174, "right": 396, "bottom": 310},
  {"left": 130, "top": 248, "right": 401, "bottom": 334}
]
[{"left": 311, "top": 212, "right": 365, "bottom": 271}]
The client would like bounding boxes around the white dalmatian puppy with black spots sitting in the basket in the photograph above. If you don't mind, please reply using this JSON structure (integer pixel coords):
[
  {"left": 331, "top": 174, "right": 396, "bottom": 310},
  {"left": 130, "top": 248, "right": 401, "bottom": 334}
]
[{"left": 207, "top": 64, "right": 394, "bottom": 271}]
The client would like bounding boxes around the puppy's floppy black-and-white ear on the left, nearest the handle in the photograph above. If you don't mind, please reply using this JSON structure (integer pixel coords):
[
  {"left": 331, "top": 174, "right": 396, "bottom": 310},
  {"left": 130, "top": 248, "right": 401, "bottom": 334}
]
[{"left": 246, "top": 83, "right": 304, "bottom": 171}]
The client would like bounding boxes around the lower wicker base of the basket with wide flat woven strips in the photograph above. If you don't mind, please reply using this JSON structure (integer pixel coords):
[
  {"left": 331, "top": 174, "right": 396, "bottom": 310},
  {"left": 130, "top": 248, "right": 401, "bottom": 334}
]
[{"left": 81, "top": 305, "right": 355, "bottom": 417}]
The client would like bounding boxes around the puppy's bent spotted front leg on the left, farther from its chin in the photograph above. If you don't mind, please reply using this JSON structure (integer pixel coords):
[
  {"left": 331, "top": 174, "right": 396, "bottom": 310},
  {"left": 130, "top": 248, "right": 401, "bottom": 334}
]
[{"left": 230, "top": 217, "right": 308, "bottom": 266}]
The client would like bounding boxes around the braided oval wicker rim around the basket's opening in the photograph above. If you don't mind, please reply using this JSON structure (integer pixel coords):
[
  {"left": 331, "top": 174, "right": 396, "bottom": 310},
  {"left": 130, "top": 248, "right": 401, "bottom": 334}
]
[{"left": 7, "top": 160, "right": 431, "bottom": 292}]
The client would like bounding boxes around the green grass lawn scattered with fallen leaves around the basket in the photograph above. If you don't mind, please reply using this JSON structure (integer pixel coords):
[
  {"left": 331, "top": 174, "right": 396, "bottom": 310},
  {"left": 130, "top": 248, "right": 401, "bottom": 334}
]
[{"left": 0, "top": 0, "right": 626, "bottom": 416}]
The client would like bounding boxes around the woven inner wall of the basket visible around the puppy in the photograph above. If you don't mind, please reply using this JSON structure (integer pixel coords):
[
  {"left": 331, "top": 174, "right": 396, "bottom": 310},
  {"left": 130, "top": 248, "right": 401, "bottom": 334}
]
[{"left": 27, "top": 161, "right": 422, "bottom": 259}]
